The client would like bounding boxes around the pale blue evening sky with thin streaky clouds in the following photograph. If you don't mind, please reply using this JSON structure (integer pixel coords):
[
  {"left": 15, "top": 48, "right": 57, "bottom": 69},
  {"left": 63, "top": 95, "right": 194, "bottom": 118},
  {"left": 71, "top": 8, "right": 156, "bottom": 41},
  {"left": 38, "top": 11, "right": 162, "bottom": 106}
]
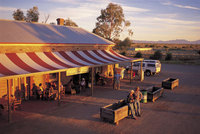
[{"left": 0, "top": 0, "right": 200, "bottom": 41}]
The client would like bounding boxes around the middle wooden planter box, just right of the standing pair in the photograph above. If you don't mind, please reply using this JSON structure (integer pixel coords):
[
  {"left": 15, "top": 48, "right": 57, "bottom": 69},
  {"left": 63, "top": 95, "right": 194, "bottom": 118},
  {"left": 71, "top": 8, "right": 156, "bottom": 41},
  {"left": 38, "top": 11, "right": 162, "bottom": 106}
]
[{"left": 147, "top": 87, "right": 164, "bottom": 102}]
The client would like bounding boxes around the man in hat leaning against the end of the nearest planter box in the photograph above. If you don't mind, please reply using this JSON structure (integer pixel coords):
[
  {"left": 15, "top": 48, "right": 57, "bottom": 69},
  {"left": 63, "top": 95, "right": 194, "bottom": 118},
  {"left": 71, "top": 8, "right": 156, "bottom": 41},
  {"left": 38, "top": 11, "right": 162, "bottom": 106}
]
[{"left": 127, "top": 90, "right": 137, "bottom": 120}]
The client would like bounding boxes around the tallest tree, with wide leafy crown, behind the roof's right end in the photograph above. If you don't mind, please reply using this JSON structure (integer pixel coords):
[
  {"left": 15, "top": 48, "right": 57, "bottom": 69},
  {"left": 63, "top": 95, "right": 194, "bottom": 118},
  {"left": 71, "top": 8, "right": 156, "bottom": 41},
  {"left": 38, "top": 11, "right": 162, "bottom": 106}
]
[{"left": 93, "top": 3, "right": 133, "bottom": 40}]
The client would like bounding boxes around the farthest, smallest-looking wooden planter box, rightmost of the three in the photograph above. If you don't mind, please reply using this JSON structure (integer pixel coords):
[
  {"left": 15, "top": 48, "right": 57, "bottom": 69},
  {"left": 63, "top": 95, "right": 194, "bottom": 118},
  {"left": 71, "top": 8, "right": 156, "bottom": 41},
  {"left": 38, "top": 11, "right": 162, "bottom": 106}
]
[{"left": 162, "top": 78, "right": 179, "bottom": 90}]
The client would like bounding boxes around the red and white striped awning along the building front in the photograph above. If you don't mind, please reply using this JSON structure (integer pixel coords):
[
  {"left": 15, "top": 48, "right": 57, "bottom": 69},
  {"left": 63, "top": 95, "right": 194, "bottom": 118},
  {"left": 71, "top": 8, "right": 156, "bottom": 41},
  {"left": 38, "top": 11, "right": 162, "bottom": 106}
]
[{"left": 0, "top": 50, "right": 136, "bottom": 78}]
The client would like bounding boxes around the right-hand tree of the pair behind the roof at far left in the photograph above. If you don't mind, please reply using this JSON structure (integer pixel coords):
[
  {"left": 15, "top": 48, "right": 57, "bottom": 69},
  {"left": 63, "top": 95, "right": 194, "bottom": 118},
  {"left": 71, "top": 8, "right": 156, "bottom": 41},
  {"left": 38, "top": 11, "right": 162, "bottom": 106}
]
[{"left": 26, "top": 6, "right": 40, "bottom": 22}]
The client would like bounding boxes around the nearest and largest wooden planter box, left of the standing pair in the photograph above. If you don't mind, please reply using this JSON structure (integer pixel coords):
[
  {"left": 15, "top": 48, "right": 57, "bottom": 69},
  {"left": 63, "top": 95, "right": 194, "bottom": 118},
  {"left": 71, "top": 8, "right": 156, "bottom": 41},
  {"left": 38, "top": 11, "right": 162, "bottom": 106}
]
[{"left": 100, "top": 100, "right": 128, "bottom": 125}]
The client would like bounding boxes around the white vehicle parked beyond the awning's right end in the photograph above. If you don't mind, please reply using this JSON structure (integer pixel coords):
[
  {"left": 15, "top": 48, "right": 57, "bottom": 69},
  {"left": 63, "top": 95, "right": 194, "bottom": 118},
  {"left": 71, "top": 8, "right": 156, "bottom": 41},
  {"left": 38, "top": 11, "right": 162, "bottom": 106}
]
[{"left": 128, "top": 60, "right": 161, "bottom": 76}]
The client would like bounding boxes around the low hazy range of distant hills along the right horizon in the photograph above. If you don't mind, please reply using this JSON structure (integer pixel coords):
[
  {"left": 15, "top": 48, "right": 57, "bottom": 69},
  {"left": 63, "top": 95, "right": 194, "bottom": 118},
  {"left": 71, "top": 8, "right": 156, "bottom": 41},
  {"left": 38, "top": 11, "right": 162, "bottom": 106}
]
[{"left": 133, "top": 39, "right": 200, "bottom": 44}]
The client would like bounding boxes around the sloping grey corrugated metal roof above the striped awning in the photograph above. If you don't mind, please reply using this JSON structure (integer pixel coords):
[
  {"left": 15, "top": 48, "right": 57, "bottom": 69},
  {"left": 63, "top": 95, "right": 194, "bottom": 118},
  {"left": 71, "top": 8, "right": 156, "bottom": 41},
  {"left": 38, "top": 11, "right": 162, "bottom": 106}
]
[{"left": 0, "top": 20, "right": 114, "bottom": 45}]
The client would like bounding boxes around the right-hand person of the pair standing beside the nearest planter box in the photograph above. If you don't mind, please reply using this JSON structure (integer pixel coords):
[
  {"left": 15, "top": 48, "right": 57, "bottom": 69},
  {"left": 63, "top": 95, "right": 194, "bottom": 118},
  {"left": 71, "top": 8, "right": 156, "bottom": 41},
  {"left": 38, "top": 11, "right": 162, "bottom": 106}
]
[{"left": 134, "top": 87, "right": 143, "bottom": 117}]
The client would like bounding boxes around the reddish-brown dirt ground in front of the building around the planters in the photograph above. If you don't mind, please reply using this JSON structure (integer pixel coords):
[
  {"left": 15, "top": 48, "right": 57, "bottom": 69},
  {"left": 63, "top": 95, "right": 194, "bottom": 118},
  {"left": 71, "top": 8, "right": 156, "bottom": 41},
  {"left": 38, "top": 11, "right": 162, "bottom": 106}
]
[{"left": 0, "top": 64, "right": 200, "bottom": 134}]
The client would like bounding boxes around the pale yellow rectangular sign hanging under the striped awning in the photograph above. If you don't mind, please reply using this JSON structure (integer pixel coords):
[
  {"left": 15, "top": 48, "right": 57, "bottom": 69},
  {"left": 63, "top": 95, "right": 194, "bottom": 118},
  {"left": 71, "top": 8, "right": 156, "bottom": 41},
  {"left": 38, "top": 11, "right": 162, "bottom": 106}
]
[{"left": 66, "top": 67, "right": 89, "bottom": 76}]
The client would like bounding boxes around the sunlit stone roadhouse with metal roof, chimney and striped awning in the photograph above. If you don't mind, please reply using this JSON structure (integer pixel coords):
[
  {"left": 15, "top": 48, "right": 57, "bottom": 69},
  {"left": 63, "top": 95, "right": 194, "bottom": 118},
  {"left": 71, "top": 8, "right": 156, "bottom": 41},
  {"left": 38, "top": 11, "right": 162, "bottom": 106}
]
[{"left": 0, "top": 18, "right": 143, "bottom": 122}]
